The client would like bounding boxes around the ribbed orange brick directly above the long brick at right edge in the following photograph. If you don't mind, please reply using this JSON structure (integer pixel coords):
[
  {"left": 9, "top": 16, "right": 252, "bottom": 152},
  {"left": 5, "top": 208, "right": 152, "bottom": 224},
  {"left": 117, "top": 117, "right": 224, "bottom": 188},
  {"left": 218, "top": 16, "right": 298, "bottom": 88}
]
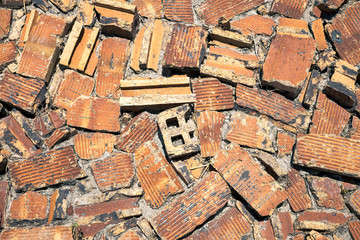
[{"left": 310, "top": 93, "right": 350, "bottom": 136}]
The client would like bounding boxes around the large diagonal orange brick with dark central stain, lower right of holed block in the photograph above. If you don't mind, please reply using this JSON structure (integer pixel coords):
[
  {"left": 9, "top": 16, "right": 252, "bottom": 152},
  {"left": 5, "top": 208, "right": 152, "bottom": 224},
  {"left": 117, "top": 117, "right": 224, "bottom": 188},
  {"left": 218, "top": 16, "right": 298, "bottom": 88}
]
[{"left": 212, "top": 145, "right": 287, "bottom": 216}]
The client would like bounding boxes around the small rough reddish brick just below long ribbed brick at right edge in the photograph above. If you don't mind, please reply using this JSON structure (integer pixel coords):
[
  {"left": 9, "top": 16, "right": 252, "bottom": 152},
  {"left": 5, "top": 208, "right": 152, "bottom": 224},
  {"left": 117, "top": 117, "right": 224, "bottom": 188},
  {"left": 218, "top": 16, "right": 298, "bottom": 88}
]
[{"left": 308, "top": 176, "right": 344, "bottom": 210}]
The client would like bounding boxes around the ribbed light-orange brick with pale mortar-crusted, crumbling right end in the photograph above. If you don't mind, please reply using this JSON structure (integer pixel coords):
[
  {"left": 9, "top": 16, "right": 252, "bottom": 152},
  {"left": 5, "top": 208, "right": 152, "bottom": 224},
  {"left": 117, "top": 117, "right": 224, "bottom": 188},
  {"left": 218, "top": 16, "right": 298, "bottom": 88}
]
[{"left": 226, "top": 112, "right": 275, "bottom": 153}]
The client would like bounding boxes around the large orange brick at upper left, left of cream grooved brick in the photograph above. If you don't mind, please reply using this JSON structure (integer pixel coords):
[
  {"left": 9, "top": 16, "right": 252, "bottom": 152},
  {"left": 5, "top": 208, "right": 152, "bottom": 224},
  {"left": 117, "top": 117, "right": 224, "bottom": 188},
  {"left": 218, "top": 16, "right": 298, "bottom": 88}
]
[{"left": 17, "top": 14, "right": 67, "bottom": 81}]
